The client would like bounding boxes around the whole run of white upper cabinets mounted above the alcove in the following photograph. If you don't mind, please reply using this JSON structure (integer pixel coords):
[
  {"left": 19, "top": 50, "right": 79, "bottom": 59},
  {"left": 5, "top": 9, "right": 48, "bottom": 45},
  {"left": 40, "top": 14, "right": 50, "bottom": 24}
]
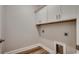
[{"left": 36, "top": 5, "right": 77, "bottom": 23}]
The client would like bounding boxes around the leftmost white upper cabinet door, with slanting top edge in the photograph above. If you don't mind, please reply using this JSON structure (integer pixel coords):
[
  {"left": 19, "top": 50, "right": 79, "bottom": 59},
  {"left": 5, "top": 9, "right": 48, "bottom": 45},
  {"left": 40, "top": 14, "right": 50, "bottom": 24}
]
[{"left": 36, "top": 6, "right": 47, "bottom": 22}]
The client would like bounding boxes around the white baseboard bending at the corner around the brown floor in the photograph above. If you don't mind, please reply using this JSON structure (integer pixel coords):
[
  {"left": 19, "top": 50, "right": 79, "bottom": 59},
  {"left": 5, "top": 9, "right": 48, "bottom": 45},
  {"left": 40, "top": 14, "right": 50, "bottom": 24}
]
[{"left": 4, "top": 43, "right": 55, "bottom": 54}]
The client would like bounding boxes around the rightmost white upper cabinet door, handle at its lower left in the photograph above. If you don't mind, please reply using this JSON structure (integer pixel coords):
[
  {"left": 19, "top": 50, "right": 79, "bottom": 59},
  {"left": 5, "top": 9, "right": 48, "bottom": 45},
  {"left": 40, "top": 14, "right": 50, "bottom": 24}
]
[{"left": 61, "top": 5, "right": 76, "bottom": 20}]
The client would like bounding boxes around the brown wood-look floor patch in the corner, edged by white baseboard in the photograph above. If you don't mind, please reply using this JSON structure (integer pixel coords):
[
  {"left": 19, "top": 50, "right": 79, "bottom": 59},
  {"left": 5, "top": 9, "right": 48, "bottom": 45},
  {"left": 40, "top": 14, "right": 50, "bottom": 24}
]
[{"left": 17, "top": 46, "right": 49, "bottom": 54}]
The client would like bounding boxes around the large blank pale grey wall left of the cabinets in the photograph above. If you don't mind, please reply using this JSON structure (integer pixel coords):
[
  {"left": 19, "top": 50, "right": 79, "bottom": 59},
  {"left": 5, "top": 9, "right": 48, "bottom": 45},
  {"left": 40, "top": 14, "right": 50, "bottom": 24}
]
[{"left": 3, "top": 6, "right": 39, "bottom": 52}]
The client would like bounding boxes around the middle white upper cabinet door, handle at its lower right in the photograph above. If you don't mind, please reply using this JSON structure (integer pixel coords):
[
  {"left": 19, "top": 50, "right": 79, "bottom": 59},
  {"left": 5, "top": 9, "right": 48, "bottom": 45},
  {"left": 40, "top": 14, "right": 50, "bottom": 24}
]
[{"left": 48, "top": 5, "right": 60, "bottom": 21}]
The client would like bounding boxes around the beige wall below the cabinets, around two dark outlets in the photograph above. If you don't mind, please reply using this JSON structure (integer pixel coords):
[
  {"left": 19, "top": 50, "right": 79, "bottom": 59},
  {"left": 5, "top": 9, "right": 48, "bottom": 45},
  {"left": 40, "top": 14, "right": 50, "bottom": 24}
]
[{"left": 40, "top": 22, "right": 76, "bottom": 53}]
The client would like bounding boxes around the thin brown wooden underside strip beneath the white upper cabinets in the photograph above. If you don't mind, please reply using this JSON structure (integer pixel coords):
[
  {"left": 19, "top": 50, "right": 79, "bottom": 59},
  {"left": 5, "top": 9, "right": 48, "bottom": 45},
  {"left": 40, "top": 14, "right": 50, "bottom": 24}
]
[{"left": 36, "top": 18, "right": 76, "bottom": 26}]
